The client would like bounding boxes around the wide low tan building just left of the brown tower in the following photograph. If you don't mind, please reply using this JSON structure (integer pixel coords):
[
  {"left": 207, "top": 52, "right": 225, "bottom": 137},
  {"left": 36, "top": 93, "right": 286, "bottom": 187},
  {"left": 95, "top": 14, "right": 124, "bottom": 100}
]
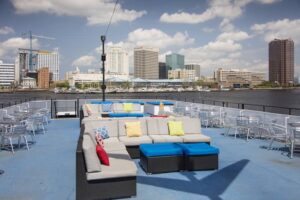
[{"left": 215, "top": 68, "right": 265, "bottom": 88}]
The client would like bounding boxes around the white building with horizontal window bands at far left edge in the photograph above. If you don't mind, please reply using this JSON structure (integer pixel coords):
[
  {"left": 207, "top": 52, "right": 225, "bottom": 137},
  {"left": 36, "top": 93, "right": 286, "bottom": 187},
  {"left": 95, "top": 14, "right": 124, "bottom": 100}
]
[{"left": 0, "top": 60, "right": 15, "bottom": 87}]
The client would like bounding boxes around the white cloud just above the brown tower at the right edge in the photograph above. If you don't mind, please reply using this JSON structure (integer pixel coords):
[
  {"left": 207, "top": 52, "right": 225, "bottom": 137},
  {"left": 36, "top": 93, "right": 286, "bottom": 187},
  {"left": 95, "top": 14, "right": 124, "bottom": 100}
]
[{"left": 251, "top": 19, "right": 300, "bottom": 44}]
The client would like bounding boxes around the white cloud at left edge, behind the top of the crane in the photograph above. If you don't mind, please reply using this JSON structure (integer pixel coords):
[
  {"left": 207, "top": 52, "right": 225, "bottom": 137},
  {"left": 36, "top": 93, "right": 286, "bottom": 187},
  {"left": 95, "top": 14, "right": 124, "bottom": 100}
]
[{"left": 0, "top": 37, "right": 39, "bottom": 58}]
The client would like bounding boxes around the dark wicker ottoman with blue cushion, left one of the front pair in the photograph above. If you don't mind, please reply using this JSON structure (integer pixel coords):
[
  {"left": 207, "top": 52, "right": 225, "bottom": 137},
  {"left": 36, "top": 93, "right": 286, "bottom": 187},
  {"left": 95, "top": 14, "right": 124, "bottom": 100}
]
[{"left": 140, "top": 143, "right": 184, "bottom": 174}]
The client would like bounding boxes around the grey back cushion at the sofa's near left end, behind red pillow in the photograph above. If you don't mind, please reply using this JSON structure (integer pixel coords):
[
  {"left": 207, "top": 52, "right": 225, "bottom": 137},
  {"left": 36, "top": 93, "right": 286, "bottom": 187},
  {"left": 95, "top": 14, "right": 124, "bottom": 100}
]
[{"left": 82, "top": 135, "right": 101, "bottom": 172}]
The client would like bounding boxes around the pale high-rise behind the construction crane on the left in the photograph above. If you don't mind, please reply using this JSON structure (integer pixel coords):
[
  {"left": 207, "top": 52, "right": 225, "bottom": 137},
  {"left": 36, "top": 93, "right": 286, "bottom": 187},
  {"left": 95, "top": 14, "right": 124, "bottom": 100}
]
[{"left": 16, "top": 49, "right": 59, "bottom": 82}]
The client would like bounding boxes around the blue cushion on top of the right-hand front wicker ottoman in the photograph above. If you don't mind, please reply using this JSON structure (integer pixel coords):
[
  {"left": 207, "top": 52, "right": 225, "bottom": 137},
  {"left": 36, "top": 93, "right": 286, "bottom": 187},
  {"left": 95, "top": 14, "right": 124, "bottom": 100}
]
[{"left": 177, "top": 143, "right": 219, "bottom": 156}]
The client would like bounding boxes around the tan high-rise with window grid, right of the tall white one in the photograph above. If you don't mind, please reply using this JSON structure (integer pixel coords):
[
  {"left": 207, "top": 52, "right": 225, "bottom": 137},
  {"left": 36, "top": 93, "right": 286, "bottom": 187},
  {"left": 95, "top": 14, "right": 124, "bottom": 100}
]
[{"left": 134, "top": 47, "right": 159, "bottom": 79}]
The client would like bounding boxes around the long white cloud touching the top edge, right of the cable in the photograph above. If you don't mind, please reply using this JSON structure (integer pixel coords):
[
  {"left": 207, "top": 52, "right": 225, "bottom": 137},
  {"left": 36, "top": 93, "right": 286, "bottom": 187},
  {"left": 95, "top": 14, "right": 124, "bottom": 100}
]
[{"left": 160, "top": 0, "right": 277, "bottom": 24}]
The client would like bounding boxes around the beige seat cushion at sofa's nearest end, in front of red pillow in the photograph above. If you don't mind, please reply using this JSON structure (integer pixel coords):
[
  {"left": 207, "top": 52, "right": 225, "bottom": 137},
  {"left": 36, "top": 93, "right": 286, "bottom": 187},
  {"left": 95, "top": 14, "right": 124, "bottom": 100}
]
[{"left": 86, "top": 150, "right": 137, "bottom": 181}]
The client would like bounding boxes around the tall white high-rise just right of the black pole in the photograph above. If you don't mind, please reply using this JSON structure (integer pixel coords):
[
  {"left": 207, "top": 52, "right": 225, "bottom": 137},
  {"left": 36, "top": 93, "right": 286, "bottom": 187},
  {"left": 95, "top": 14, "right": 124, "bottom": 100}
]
[{"left": 105, "top": 46, "right": 129, "bottom": 75}]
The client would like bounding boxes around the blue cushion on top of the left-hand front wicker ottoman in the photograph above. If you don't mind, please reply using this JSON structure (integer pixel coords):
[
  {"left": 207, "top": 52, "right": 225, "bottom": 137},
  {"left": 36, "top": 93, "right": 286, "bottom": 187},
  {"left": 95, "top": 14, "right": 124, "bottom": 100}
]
[{"left": 140, "top": 143, "right": 183, "bottom": 157}]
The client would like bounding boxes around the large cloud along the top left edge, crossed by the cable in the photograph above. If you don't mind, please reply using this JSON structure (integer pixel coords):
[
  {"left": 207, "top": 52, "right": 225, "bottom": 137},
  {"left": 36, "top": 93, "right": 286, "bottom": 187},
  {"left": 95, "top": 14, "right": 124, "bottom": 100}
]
[{"left": 11, "top": 0, "right": 146, "bottom": 25}]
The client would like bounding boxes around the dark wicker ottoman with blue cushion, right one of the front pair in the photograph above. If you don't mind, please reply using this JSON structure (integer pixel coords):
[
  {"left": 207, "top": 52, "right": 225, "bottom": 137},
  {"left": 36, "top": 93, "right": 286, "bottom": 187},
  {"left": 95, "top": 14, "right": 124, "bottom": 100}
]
[{"left": 177, "top": 143, "right": 219, "bottom": 171}]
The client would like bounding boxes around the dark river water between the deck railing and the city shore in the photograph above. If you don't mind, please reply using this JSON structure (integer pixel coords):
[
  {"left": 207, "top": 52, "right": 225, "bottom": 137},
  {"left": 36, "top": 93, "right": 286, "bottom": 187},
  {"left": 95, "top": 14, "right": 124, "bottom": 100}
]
[{"left": 0, "top": 89, "right": 300, "bottom": 115}]
